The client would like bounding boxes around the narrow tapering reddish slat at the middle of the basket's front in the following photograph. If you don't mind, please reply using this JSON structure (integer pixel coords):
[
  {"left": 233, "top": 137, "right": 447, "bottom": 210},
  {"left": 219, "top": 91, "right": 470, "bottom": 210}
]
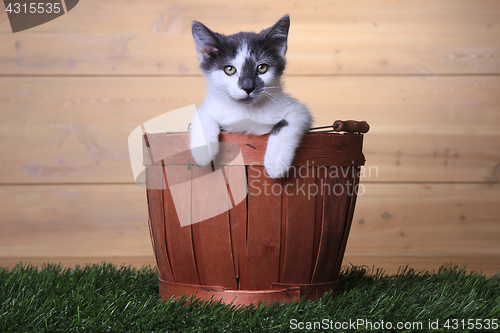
[{"left": 227, "top": 166, "right": 247, "bottom": 285}]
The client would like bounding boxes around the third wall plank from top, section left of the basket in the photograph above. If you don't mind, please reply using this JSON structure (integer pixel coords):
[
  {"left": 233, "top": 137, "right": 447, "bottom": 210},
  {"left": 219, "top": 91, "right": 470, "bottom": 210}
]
[{"left": 0, "top": 184, "right": 153, "bottom": 258}]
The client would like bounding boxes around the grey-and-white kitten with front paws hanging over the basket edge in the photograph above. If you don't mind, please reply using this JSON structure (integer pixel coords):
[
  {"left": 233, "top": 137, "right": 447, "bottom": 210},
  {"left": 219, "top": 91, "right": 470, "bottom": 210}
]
[{"left": 191, "top": 15, "right": 312, "bottom": 178}]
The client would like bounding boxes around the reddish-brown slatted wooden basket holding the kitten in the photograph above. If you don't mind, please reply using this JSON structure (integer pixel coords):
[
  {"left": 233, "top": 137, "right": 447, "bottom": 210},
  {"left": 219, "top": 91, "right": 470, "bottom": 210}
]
[{"left": 144, "top": 133, "right": 365, "bottom": 305}]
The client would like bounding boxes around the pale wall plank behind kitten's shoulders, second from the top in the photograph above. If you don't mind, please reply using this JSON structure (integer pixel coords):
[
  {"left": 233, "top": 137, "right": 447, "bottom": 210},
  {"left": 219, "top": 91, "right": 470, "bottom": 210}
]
[{"left": 0, "top": 77, "right": 500, "bottom": 183}]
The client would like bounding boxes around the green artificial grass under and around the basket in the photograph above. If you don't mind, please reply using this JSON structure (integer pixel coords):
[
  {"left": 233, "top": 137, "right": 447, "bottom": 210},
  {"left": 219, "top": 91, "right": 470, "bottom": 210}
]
[{"left": 0, "top": 263, "right": 500, "bottom": 332}]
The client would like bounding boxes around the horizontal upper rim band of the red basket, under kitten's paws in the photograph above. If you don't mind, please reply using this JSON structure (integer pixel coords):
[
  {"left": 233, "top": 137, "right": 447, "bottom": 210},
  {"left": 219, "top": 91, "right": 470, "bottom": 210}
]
[{"left": 143, "top": 132, "right": 365, "bottom": 167}]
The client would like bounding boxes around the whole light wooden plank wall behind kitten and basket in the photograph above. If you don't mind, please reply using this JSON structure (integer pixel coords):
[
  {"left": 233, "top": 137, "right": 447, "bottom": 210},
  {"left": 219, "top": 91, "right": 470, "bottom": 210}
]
[{"left": 0, "top": 0, "right": 500, "bottom": 273}]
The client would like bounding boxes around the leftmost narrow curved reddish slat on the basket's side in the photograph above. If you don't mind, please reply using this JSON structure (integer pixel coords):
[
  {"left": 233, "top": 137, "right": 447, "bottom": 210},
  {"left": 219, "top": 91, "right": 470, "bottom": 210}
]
[{"left": 146, "top": 165, "right": 175, "bottom": 282}]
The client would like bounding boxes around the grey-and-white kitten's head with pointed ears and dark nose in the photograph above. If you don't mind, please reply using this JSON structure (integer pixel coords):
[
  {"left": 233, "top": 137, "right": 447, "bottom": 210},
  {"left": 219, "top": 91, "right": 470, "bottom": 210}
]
[{"left": 192, "top": 15, "right": 290, "bottom": 104}]
